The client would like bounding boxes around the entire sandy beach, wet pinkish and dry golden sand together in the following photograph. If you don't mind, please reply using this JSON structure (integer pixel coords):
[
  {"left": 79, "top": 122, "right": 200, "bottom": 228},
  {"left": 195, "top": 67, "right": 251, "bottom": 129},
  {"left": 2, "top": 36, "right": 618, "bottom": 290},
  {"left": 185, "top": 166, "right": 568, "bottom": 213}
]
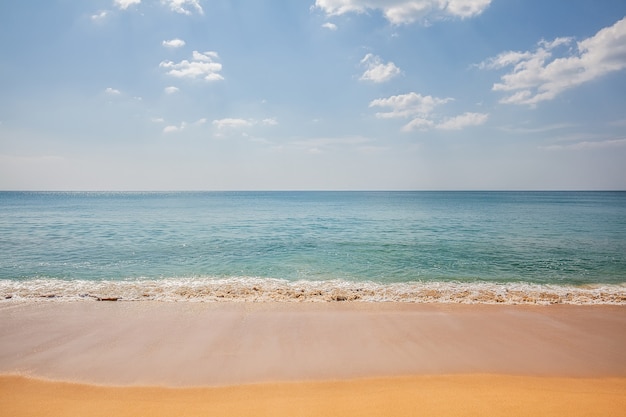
[{"left": 0, "top": 301, "right": 626, "bottom": 416}]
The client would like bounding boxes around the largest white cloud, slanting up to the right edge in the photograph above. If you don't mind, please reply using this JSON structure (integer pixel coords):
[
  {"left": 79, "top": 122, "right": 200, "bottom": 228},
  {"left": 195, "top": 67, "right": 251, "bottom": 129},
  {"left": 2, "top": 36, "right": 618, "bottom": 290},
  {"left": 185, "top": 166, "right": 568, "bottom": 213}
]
[{"left": 478, "top": 18, "right": 626, "bottom": 105}]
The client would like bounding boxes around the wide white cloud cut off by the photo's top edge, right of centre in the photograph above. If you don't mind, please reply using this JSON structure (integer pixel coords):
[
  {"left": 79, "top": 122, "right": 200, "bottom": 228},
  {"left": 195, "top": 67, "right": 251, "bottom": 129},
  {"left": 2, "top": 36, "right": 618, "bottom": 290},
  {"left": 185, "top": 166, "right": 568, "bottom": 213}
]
[{"left": 315, "top": 0, "right": 491, "bottom": 25}]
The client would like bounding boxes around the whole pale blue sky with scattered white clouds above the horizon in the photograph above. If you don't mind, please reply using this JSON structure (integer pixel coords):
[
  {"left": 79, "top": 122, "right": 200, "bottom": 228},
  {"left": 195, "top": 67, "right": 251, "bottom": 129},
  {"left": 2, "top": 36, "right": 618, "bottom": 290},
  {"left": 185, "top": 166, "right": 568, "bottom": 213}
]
[{"left": 0, "top": 0, "right": 626, "bottom": 190}]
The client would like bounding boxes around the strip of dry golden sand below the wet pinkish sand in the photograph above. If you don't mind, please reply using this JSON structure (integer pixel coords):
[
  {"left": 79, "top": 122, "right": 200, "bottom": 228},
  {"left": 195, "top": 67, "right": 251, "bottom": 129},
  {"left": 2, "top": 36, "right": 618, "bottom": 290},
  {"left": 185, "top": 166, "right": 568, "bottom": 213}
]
[{"left": 0, "top": 375, "right": 626, "bottom": 417}]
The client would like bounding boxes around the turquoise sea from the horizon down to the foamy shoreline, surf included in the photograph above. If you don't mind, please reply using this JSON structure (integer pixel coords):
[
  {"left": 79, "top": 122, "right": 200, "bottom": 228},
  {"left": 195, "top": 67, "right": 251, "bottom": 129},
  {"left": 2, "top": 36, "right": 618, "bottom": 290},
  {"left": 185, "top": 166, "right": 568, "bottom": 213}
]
[{"left": 0, "top": 191, "right": 626, "bottom": 304}]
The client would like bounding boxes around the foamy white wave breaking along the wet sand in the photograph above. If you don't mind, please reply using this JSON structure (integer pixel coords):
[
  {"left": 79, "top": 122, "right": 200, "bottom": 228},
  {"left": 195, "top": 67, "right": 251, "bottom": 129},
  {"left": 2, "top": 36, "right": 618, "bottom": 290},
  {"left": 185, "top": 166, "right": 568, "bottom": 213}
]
[{"left": 0, "top": 277, "right": 626, "bottom": 305}]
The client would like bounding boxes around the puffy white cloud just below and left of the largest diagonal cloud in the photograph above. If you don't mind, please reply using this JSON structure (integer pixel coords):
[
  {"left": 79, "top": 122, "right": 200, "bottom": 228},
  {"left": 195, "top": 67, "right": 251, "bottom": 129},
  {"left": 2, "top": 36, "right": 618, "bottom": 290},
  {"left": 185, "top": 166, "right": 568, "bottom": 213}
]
[{"left": 369, "top": 92, "right": 488, "bottom": 132}]
